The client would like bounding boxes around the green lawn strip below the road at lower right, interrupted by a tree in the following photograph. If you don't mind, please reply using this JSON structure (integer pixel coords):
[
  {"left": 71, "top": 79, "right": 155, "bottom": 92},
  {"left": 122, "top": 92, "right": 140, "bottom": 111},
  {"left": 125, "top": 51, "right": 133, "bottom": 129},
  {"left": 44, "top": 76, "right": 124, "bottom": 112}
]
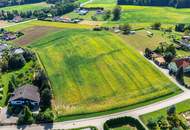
[{"left": 140, "top": 100, "right": 190, "bottom": 124}]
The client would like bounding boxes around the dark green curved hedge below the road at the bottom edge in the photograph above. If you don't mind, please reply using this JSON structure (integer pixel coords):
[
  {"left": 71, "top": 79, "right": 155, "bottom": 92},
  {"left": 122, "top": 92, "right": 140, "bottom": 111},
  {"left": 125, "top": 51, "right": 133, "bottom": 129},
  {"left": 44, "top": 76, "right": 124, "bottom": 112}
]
[{"left": 104, "top": 116, "right": 146, "bottom": 130}]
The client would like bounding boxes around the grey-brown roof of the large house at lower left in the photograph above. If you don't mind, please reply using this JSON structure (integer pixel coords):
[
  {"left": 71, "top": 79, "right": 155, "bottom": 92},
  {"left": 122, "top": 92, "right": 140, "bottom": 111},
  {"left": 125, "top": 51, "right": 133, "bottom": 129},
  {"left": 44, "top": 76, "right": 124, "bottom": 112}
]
[{"left": 9, "top": 84, "right": 40, "bottom": 102}]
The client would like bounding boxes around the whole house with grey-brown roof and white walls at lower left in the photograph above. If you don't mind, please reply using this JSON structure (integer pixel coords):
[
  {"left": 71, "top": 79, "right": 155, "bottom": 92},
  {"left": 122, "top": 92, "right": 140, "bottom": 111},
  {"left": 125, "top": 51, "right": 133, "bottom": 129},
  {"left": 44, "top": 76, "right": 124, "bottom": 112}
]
[{"left": 8, "top": 84, "right": 40, "bottom": 108}]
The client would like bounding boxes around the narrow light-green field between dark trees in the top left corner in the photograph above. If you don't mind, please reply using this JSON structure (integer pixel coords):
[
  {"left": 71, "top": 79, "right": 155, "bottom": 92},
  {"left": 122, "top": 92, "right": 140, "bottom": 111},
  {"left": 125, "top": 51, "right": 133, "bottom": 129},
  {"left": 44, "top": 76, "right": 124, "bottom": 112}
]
[{"left": 0, "top": 2, "right": 50, "bottom": 12}]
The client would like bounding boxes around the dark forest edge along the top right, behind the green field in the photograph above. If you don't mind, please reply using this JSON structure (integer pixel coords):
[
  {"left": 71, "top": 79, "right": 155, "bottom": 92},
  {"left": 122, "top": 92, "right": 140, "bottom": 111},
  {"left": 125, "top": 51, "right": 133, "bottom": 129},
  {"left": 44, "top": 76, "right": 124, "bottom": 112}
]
[{"left": 118, "top": 0, "right": 190, "bottom": 8}]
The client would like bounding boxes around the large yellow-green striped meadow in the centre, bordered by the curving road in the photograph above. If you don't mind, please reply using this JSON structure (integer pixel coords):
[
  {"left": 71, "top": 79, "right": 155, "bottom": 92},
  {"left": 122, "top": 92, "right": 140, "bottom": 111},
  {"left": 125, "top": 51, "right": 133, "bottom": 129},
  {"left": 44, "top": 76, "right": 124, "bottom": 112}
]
[{"left": 29, "top": 29, "right": 180, "bottom": 116}]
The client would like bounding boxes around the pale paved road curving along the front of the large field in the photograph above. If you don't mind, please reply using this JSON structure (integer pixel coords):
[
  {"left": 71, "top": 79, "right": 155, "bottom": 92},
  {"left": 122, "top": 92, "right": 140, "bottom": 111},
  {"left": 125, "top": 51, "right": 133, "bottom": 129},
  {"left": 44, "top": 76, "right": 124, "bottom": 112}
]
[{"left": 0, "top": 61, "right": 190, "bottom": 130}]
